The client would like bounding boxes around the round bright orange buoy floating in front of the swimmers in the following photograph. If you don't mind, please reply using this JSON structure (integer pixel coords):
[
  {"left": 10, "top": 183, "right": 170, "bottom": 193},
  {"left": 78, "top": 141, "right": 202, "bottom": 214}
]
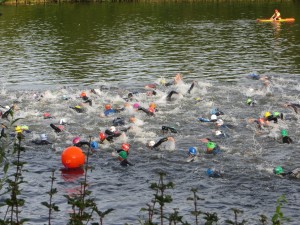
[{"left": 61, "top": 146, "right": 85, "bottom": 169}]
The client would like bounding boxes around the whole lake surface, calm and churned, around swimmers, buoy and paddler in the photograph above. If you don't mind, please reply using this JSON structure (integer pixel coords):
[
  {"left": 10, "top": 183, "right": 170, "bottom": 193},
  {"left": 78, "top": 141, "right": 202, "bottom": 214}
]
[{"left": 0, "top": 2, "right": 300, "bottom": 225}]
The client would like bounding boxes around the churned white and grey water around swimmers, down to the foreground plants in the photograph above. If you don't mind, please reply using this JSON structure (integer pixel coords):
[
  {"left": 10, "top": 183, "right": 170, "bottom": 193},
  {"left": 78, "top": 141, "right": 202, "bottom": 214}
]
[{"left": 1, "top": 76, "right": 300, "bottom": 225}]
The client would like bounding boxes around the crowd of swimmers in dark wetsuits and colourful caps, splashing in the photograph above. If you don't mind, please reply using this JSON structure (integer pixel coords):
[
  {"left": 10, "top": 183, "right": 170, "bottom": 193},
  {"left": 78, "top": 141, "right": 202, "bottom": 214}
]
[{"left": 0, "top": 74, "right": 300, "bottom": 177}]
